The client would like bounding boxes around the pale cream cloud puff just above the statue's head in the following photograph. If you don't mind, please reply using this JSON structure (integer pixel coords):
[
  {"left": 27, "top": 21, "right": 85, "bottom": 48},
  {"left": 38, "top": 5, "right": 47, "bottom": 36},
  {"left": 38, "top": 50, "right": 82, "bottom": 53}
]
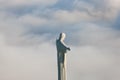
[{"left": 54, "top": 10, "right": 93, "bottom": 24}]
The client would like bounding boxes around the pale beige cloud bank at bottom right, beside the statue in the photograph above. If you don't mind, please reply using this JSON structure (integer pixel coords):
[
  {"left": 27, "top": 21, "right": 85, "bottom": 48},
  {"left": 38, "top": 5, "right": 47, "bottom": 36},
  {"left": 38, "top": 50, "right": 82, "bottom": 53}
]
[{"left": 68, "top": 46, "right": 120, "bottom": 80}]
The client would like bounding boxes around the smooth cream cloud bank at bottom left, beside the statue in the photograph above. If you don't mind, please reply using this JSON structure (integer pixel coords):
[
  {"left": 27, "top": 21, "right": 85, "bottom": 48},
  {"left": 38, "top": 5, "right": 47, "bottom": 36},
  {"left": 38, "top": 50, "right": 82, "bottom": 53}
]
[{"left": 0, "top": 35, "right": 57, "bottom": 80}]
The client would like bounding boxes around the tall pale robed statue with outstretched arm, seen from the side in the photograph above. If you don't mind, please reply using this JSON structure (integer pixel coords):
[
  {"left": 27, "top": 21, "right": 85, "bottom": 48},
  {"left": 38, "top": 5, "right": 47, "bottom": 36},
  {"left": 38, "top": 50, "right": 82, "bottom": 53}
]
[{"left": 56, "top": 33, "right": 70, "bottom": 80}]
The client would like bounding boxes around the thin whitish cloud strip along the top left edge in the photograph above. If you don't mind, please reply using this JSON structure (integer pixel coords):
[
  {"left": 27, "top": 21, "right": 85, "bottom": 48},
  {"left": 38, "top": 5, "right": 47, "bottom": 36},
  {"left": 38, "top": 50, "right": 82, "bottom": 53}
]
[{"left": 0, "top": 0, "right": 57, "bottom": 8}]
